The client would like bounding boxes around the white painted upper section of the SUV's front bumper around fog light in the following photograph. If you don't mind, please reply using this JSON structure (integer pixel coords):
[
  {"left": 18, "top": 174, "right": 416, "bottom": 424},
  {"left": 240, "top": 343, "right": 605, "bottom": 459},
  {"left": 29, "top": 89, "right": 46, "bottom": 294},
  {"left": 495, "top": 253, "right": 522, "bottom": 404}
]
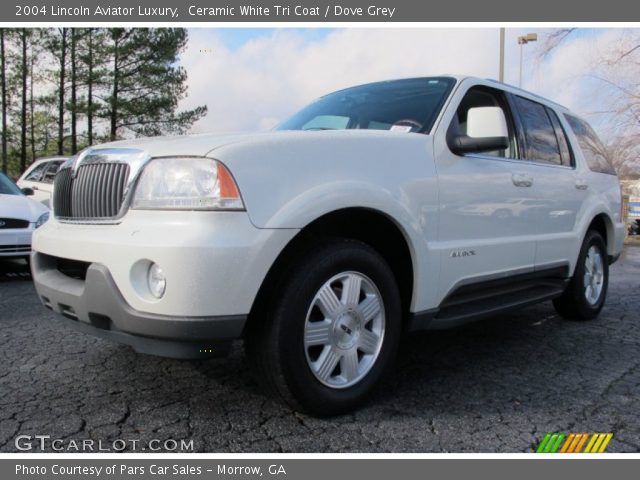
[{"left": 33, "top": 210, "right": 297, "bottom": 317}]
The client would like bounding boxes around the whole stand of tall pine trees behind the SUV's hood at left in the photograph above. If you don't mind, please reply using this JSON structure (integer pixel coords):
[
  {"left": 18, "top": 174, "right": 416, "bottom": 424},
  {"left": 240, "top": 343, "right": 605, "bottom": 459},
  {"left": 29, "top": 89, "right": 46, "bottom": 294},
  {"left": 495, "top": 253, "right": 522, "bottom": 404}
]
[{"left": 0, "top": 27, "right": 206, "bottom": 175}]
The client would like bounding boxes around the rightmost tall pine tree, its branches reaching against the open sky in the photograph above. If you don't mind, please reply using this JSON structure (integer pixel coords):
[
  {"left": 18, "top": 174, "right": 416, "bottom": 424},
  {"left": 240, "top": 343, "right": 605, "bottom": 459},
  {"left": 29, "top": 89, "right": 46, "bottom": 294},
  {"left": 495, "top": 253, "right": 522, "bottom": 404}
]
[{"left": 102, "top": 28, "right": 207, "bottom": 140}]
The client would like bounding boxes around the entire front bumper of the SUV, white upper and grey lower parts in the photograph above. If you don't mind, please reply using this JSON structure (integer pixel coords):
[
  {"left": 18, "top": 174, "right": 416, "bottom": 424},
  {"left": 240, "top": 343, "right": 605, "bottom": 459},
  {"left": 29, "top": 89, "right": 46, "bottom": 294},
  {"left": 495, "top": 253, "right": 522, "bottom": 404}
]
[{"left": 31, "top": 211, "right": 297, "bottom": 358}]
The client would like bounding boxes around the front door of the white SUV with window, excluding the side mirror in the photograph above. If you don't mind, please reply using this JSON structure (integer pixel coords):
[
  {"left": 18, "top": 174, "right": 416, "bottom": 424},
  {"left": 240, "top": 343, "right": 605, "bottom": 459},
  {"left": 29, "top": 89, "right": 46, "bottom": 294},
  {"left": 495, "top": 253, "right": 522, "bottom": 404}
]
[{"left": 434, "top": 85, "right": 540, "bottom": 301}]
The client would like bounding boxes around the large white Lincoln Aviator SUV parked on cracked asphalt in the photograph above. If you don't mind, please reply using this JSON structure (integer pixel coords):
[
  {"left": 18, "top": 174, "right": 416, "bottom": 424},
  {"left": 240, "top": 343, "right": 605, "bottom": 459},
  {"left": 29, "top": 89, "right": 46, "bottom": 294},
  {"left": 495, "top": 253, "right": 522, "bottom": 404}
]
[{"left": 32, "top": 77, "right": 624, "bottom": 414}]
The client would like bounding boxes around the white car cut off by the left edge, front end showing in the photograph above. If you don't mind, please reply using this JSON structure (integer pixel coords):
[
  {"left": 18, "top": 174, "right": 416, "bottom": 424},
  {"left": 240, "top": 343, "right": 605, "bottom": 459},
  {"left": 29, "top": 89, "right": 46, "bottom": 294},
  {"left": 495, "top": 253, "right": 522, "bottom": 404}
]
[{"left": 0, "top": 173, "right": 49, "bottom": 258}]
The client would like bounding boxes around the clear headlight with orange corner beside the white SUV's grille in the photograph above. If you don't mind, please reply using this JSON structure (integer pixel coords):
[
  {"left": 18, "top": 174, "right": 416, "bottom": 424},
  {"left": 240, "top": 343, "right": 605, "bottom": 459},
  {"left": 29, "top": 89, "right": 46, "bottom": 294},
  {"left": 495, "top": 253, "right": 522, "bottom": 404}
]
[{"left": 131, "top": 157, "right": 244, "bottom": 210}]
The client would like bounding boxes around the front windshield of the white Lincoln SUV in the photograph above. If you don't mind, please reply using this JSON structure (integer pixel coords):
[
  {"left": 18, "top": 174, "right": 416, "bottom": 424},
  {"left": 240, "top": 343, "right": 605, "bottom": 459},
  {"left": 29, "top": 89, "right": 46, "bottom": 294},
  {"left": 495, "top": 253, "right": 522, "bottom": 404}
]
[{"left": 277, "top": 77, "right": 455, "bottom": 133}]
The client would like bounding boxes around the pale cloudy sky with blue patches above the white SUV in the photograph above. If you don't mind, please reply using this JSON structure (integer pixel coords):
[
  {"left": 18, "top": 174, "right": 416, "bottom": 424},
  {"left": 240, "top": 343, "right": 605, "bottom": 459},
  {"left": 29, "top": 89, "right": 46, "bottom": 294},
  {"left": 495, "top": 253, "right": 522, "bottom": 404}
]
[{"left": 180, "top": 28, "right": 632, "bottom": 133}]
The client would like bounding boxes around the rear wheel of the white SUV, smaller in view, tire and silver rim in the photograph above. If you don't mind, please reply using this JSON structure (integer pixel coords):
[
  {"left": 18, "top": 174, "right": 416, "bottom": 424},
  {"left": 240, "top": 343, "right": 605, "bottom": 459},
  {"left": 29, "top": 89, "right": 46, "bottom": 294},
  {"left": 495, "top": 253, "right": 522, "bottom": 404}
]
[{"left": 553, "top": 230, "right": 609, "bottom": 320}]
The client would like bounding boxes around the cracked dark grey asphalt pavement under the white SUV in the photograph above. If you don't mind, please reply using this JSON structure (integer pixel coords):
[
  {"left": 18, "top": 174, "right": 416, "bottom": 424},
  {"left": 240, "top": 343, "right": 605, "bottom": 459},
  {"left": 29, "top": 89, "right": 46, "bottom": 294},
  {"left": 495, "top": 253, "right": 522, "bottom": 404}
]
[{"left": 0, "top": 247, "right": 640, "bottom": 452}]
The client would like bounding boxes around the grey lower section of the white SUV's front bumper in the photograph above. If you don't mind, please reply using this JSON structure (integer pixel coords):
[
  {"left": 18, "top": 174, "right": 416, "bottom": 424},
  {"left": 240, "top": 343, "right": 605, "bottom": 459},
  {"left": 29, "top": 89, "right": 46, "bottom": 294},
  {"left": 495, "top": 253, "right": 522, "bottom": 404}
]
[{"left": 31, "top": 253, "right": 247, "bottom": 358}]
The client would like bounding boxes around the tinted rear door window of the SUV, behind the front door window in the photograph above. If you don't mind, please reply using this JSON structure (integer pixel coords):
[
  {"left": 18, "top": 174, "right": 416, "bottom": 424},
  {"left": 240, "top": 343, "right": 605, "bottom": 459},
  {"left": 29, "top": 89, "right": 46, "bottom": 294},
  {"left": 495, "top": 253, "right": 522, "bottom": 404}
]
[{"left": 514, "top": 96, "right": 562, "bottom": 165}]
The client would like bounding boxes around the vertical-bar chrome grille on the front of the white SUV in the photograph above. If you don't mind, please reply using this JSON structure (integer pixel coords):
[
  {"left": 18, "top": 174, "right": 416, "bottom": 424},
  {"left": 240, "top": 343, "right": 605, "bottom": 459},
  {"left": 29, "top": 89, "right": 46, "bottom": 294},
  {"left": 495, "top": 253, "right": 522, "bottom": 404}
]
[{"left": 53, "top": 163, "right": 129, "bottom": 220}]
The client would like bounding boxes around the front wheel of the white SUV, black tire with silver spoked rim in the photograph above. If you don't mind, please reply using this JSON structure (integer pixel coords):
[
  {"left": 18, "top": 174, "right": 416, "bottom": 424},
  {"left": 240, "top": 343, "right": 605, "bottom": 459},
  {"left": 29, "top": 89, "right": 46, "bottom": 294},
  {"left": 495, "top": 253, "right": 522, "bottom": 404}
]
[{"left": 246, "top": 240, "right": 401, "bottom": 416}]
